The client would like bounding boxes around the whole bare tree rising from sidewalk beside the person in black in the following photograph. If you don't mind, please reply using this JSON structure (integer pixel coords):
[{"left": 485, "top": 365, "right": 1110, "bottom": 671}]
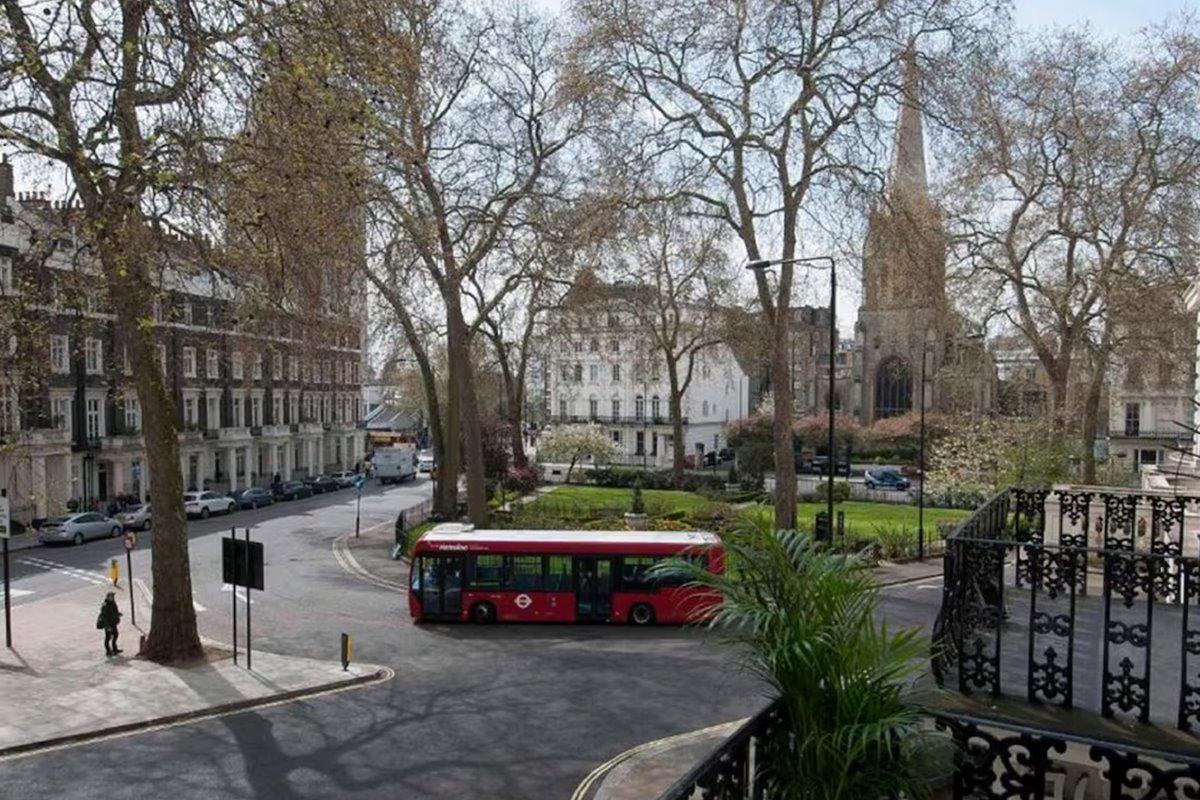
[{"left": 0, "top": 0, "right": 242, "bottom": 662}]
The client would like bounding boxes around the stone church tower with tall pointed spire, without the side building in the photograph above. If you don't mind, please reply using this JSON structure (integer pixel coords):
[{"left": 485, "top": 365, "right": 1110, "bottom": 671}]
[{"left": 857, "top": 47, "right": 958, "bottom": 423}]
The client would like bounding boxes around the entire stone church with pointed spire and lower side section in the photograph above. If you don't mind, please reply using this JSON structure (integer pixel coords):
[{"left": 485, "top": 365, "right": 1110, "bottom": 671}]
[{"left": 850, "top": 50, "right": 996, "bottom": 423}]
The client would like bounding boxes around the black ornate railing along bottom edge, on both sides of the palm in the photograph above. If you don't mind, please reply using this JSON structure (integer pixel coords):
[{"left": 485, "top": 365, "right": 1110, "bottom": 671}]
[{"left": 658, "top": 700, "right": 1200, "bottom": 800}]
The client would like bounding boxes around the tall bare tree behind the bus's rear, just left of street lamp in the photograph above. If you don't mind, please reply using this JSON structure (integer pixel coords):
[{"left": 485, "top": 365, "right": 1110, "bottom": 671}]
[{"left": 575, "top": 0, "right": 985, "bottom": 528}]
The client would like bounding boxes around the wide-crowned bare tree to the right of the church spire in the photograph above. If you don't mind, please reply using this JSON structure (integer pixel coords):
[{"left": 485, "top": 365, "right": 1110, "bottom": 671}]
[{"left": 943, "top": 25, "right": 1200, "bottom": 480}]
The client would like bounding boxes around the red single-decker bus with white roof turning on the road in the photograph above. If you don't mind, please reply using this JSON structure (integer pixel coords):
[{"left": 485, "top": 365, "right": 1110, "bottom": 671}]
[{"left": 408, "top": 523, "right": 725, "bottom": 625}]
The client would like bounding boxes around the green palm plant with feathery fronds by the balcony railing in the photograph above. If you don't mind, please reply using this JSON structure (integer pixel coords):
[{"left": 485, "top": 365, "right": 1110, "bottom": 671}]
[{"left": 659, "top": 517, "right": 949, "bottom": 800}]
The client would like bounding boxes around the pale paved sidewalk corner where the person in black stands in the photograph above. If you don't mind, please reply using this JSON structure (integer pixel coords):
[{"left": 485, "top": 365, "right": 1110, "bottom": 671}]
[{"left": 0, "top": 584, "right": 390, "bottom": 757}]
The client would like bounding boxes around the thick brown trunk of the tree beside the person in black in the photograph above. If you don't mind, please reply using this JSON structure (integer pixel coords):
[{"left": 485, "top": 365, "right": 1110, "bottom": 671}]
[{"left": 101, "top": 236, "right": 203, "bottom": 663}]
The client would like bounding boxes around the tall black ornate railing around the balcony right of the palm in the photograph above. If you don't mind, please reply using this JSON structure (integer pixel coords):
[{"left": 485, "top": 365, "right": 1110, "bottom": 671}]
[{"left": 934, "top": 489, "right": 1200, "bottom": 730}]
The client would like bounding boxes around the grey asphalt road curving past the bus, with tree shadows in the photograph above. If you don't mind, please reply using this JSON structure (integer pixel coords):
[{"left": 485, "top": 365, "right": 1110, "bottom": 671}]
[{"left": 0, "top": 480, "right": 782, "bottom": 800}]
